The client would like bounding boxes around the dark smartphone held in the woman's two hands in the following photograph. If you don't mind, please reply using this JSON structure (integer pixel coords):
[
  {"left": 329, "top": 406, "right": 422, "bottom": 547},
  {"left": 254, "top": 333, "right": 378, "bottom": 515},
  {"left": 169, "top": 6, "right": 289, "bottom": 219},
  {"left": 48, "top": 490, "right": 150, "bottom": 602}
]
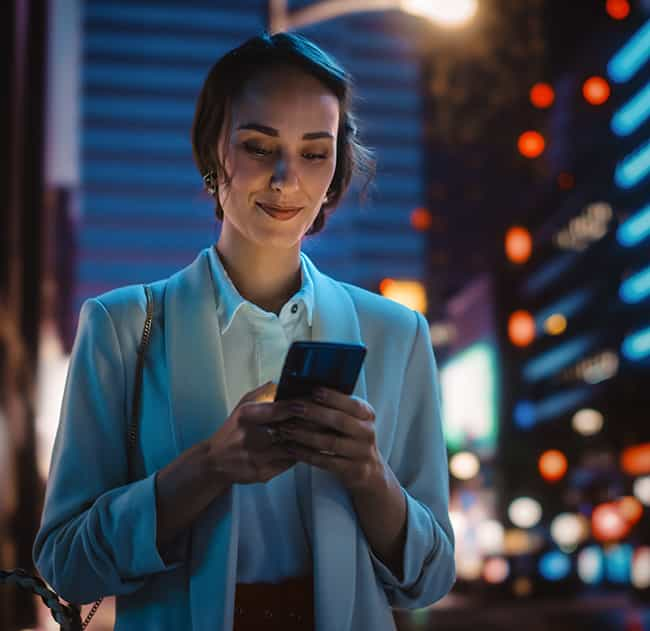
[{"left": 275, "top": 342, "right": 366, "bottom": 401}]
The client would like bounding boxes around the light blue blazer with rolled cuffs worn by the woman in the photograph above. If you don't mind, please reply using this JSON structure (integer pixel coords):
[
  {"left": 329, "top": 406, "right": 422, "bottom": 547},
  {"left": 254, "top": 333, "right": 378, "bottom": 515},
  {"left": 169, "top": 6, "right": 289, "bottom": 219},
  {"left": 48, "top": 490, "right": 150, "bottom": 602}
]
[{"left": 33, "top": 249, "right": 455, "bottom": 631}]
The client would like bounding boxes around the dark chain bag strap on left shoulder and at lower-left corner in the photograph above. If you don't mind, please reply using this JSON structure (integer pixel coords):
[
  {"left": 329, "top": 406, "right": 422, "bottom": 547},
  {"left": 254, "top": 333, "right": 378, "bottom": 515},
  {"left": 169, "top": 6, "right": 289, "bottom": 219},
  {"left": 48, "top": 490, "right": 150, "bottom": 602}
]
[{"left": 0, "top": 285, "right": 154, "bottom": 631}]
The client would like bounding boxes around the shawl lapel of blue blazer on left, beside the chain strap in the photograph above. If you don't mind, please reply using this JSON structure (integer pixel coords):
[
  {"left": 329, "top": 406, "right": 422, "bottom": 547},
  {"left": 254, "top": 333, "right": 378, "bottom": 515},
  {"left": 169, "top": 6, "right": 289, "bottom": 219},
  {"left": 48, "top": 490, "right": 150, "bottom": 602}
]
[{"left": 165, "top": 251, "right": 238, "bottom": 631}]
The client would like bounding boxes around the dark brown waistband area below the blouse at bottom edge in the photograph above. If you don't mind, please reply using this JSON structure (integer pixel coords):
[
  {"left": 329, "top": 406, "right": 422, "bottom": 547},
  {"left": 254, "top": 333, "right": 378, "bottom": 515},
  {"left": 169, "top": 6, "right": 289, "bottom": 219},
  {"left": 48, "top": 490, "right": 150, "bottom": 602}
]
[{"left": 233, "top": 574, "right": 314, "bottom": 631}]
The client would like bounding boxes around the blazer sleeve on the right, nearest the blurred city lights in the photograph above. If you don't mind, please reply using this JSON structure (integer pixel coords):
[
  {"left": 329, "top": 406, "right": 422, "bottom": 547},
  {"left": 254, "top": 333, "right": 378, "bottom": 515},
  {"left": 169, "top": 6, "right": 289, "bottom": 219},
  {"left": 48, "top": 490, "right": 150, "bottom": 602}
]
[{"left": 369, "top": 311, "right": 456, "bottom": 609}]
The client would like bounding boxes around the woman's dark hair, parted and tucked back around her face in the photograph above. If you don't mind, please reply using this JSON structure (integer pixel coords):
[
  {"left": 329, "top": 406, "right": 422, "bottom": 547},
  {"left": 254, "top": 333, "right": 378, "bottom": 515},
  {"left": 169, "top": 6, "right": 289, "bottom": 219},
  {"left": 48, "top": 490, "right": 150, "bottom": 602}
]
[{"left": 192, "top": 33, "right": 375, "bottom": 234}]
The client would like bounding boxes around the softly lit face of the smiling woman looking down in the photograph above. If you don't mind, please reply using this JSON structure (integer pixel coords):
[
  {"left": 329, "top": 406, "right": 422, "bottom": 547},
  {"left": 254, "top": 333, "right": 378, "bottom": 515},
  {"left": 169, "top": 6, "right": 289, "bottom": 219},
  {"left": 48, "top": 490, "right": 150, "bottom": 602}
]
[{"left": 219, "top": 68, "right": 339, "bottom": 248}]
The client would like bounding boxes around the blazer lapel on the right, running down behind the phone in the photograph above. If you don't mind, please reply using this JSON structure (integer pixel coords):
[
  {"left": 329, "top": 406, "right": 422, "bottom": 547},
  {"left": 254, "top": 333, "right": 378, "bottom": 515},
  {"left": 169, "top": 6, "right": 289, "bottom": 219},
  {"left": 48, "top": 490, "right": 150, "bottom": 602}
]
[{"left": 296, "top": 253, "right": 367, "bottom": 631}]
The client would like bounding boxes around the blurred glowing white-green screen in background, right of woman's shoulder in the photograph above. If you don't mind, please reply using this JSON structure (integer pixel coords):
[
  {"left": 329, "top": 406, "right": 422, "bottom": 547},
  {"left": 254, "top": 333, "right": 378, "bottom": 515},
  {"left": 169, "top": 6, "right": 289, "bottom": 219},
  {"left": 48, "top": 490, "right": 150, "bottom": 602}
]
[{"left": 440, "top": 342, "right": 497, "bottom": 455}]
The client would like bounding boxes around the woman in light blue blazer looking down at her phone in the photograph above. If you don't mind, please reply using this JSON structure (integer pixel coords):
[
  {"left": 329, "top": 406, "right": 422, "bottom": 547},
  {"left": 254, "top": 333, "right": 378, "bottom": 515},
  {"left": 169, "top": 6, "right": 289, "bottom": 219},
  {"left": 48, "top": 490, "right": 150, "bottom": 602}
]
[{"left": 34, "top": 34, "right": 455, "bottom": 631}]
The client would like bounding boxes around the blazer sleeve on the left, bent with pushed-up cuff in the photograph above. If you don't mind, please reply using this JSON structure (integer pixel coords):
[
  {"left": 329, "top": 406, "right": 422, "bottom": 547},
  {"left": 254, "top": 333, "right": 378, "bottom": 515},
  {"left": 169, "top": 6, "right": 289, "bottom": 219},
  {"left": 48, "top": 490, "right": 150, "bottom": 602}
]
[{"left": 32, "top": 299, "right": 182, "bottom": 604}]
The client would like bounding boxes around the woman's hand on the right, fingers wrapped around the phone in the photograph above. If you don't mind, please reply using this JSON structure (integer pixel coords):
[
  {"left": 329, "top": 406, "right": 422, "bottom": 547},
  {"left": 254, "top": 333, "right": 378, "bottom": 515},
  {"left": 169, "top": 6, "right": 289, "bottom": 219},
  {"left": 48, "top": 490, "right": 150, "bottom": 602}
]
[{"left": 279, "top": 388, "right": 385, "bottom": 491}]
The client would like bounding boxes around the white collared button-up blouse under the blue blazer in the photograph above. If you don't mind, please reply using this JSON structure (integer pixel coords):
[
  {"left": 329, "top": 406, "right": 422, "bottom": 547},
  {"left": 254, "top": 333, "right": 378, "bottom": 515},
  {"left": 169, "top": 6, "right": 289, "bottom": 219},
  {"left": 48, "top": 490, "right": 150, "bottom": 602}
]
[{"left": 204, "top": 247, "right": 314, "bottom": 583}]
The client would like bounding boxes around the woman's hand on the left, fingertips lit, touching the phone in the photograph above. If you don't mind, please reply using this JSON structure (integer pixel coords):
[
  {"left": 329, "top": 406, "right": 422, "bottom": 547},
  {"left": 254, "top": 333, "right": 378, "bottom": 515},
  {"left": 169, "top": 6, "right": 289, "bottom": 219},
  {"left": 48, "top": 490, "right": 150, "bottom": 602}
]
[{"left": 207, "top": 382, "right": 296, "bottom": 484}]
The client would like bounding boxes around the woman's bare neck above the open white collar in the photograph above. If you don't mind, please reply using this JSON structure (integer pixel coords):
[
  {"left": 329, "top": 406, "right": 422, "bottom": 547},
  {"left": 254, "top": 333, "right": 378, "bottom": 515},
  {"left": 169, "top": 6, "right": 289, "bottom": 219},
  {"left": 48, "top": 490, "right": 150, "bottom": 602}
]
[{"left": 214, "top": 239, "right": 302, "bottom": 314}]
